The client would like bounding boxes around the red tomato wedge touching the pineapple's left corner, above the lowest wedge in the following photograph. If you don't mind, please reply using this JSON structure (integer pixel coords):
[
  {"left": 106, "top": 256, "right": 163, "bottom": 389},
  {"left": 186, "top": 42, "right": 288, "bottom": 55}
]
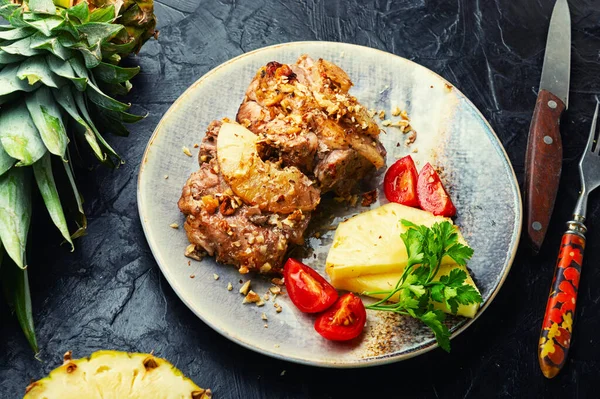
[{"left": 283, "top": 258, "right": 338, "bottom": 313}]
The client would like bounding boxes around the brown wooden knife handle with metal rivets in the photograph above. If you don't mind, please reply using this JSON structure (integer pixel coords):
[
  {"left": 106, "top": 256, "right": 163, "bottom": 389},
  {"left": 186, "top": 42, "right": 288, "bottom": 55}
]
[{"left": 525, "top": 90, "right": 565, "bottom": 252}]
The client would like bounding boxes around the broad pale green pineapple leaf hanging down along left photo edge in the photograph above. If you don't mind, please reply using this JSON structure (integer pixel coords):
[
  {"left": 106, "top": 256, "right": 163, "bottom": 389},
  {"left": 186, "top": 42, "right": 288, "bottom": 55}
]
[{"left": 0, "top": 168, "right": 31, "bottom": 269}]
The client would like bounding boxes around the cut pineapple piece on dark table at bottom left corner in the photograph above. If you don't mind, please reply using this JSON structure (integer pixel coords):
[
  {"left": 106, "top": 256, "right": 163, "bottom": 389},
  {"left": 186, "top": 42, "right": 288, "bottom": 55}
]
[{"left": 23, "top": 351, "right": 212, "bottom": 399}]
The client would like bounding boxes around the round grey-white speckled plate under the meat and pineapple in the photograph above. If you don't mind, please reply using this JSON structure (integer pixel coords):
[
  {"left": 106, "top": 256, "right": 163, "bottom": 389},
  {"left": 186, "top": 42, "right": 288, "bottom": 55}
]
[{"left": 138, "top": 42, "right": 522, "bottom": 367}]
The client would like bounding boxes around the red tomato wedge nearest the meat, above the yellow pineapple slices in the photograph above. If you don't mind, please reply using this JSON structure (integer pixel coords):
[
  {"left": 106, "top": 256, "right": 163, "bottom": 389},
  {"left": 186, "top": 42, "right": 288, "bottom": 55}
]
[{"left": 383, "top": 155, "right": 419, "bottom": 207}]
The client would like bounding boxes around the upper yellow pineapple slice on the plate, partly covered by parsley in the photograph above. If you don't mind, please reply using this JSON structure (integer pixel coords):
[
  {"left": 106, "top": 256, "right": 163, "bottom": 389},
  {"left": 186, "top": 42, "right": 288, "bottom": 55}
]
[{"left": 325, "top": 203, "right": 466, "bottom": 287}]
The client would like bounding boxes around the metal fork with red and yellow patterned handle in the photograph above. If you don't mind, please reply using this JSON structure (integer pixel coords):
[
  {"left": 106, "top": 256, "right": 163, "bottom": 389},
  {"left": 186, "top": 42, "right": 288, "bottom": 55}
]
[{"left": 538, "top": 99, "right": 600, "bottom": 378}]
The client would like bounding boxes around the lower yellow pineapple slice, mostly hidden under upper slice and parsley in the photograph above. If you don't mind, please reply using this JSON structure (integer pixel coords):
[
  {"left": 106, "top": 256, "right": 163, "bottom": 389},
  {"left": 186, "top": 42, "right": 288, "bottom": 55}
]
[{"left": 335, "top": 264, "right": 479, "bottom": 318}]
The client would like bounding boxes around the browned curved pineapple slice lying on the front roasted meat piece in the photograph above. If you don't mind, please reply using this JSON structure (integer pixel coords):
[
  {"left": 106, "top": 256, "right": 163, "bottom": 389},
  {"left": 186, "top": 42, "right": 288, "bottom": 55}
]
[{"left": 217, "top": 122, "right": 320, "bottom": 214}]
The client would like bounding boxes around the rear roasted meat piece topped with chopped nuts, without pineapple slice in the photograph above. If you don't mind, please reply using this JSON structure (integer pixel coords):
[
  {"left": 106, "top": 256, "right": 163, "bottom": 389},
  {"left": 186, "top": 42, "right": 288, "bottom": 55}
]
[{"left": 237, "top": 56, "right": 386, "bottom": 196}]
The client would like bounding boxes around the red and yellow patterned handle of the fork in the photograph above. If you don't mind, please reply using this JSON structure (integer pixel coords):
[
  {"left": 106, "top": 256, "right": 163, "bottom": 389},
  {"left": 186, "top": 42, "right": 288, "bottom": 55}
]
[{"left": 538, "top": 232, "right": 585, "bottom": 378}]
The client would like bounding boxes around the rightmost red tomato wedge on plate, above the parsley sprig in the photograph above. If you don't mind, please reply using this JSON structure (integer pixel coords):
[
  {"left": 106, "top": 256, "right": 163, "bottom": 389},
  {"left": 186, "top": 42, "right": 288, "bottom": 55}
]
[{"left": 417, "top": 163, "right": 456, "bottom": 217}]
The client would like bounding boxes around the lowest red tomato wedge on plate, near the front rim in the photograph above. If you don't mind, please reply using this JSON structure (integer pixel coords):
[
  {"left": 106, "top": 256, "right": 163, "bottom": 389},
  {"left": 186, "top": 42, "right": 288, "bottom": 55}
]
[{"left": 315, "top": 292, "right": 367, "bottom": 341}]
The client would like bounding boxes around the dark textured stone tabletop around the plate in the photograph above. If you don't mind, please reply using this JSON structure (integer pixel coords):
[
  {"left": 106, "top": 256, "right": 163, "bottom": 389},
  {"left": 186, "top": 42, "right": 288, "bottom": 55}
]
[{"left": 0, "top": 0, "right": 600, "bottom": 398}]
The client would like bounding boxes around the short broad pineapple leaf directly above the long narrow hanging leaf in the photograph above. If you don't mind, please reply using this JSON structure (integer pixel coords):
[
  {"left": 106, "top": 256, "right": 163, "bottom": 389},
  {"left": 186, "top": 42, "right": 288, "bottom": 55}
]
[{"left": 25, "top": 87, "right": 69, "bottom": 158}]
